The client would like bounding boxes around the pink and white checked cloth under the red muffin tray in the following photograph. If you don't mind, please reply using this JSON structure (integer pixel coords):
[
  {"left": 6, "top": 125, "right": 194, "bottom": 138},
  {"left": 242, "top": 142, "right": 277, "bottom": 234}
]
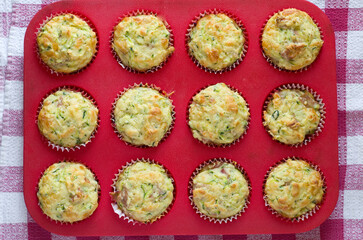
[{"left": 0, "top": 0, "right": 363, "bottom": 240}]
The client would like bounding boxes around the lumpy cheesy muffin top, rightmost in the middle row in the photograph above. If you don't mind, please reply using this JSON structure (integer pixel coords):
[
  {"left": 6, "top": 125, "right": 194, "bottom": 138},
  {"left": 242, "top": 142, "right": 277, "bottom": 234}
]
[{"left": 263, "top": 89, "right": 320, "bottom": 144}]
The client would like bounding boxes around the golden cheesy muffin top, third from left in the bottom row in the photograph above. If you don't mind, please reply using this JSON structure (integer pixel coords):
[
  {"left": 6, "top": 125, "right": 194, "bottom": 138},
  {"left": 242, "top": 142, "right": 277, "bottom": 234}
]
[{"left": 193, "top": 163, "right": 249, "bottom": 218}]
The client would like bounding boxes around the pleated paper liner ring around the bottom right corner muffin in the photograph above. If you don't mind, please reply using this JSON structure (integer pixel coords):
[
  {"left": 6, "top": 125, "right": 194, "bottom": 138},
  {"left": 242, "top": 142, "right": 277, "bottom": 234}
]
[{"left": 262, "top": 156, "right": 327, "bottom": 222}]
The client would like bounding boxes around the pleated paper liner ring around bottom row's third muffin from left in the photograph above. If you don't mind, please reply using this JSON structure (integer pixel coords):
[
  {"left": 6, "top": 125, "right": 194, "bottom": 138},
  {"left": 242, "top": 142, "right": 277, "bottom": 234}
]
[{"left": 188, "top": 158, "right": 252, "bottom": 224}]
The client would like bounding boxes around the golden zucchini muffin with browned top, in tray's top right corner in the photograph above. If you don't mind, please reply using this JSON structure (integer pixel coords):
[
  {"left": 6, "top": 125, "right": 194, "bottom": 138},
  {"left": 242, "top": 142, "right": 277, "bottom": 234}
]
[{"left": 262, "top": 8, "right": 324, "bottom": 71}]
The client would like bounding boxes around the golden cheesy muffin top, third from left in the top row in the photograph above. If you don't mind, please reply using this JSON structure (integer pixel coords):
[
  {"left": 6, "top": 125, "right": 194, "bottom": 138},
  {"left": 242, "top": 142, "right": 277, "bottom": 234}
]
[{"left": 188, "top": 13, "right": 245, "bottom": 70}]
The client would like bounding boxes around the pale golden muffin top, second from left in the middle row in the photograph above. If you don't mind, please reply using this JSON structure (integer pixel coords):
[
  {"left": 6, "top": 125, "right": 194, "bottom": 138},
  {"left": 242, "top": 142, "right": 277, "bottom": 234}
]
[{"left": 114, "top": 87, "right": 173, "bottom": 147}]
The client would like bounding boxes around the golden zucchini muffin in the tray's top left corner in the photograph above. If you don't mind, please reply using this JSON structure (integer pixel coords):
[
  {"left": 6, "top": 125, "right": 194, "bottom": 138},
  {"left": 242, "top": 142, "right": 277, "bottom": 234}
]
[{"left": 37, "top": 14, "right": 97, "bottom": 73}]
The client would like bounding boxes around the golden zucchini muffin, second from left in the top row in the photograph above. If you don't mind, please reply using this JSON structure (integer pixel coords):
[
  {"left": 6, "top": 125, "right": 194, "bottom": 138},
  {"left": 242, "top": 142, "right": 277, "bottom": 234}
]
[{"left": 112, "top": 15, "right": 174, "bottom": 72}]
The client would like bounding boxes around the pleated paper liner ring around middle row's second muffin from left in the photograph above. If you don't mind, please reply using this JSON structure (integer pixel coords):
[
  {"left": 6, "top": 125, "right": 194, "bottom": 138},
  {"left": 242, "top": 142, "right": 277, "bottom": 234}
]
[{"left": 111, "top": 82, "right": 175, "bottom": 148}]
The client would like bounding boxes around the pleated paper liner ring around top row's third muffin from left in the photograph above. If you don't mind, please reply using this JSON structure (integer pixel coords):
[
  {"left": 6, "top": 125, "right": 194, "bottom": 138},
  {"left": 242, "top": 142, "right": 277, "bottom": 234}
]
[{"left": 185, "top": 9, "right": 248, "bottom": 74}]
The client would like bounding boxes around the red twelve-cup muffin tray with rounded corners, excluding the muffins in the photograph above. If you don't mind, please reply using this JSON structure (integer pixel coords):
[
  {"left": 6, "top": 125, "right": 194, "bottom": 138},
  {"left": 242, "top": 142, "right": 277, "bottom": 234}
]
[{"left": 24, "top": 0, "right": 339, "bottom": 236}]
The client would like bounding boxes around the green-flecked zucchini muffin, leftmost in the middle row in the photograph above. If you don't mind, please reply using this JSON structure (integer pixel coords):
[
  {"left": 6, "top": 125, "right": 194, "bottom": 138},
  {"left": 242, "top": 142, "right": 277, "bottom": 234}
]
[{"left": 38, "top": 89, "right": 98, "bottom": 148}]
